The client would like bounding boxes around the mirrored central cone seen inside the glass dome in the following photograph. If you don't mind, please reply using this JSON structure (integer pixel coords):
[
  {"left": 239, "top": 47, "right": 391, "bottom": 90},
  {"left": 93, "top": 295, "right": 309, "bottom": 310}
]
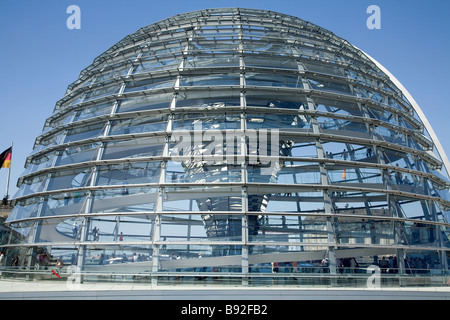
[{"left": 183, "top": 139, "right": 293, "bottom": 240}]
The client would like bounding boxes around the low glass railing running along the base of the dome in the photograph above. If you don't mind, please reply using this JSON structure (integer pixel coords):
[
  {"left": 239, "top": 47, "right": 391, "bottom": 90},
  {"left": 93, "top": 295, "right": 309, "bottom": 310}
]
[{"left": 0, "top": 262, "right": 450, "bottom": 290}]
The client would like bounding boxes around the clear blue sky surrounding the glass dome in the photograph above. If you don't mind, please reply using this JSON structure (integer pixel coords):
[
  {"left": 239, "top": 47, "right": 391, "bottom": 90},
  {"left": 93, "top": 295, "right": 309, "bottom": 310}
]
[{"left": 0, "top": 0, "right": 450, "bottom": 197}]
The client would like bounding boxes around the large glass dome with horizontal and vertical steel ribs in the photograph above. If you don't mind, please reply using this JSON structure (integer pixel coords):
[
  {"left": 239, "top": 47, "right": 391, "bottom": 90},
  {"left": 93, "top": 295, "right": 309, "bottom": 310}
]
[{"left": 2, "top": 8, "right": 450, "bottom": 284}]
